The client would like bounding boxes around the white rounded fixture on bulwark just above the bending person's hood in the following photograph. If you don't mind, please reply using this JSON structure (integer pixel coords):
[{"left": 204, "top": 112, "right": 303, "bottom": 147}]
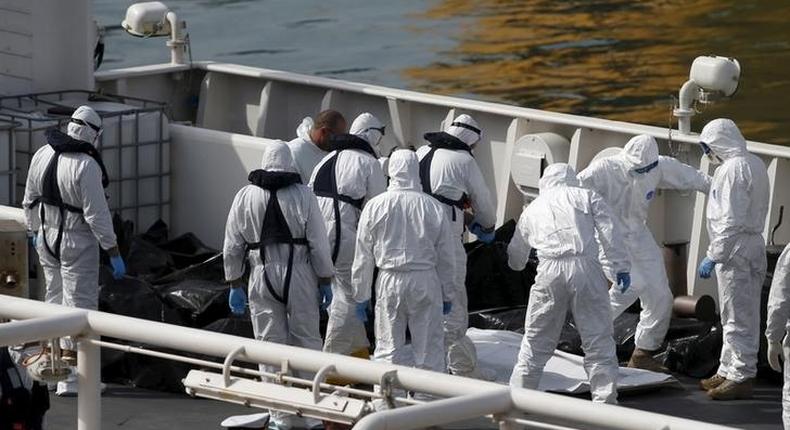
[{"left": 510, "top": 133, "right": 571, "bottom": 197}]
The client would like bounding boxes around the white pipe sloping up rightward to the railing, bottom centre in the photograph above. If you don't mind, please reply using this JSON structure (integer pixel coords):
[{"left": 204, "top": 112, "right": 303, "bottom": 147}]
[{"left": 354, "top": 385, "right": 513, "bottom": 430}]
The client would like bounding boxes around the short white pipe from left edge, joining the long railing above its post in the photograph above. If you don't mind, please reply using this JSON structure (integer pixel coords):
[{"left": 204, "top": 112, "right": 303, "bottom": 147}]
[{"left": 0, "top": 310, "right": 88, "bottom": 345}]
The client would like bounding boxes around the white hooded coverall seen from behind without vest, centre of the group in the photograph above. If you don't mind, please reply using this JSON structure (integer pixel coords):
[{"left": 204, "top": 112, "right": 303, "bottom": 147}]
[{"left": 351, "top": 150, "right": 457, "bottom": 372}]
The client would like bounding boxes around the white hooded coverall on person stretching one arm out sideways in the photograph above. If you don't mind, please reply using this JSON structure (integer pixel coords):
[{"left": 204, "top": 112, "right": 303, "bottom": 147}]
[{"left": 578, "top": 135, "right": 710, "bottom": 351}]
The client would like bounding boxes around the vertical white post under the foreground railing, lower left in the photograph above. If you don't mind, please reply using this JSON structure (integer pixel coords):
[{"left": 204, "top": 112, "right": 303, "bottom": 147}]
[{"left": 77, "top": 334, "right": 101, "bottom": 430}]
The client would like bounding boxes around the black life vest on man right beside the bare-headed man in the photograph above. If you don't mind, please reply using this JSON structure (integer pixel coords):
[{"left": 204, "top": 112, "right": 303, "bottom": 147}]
[{"left": 313, "top": 134, "right": 377, "bottom": 263}]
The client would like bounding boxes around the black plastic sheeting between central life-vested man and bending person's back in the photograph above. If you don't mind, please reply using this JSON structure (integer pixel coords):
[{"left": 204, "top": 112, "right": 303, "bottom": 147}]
[{"left": 465, "top": 220, "right": 537, "bottom": 311}]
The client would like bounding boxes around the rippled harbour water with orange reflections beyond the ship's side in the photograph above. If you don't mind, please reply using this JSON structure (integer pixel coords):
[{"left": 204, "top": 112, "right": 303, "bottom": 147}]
[{"left": 94, "top": 0, "right": 790, "bottom": 145}]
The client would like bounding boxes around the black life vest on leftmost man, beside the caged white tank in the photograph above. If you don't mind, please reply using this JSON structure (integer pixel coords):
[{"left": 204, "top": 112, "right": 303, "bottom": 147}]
[{"left": 28, "top": 128, "right": 110, "bottom": 261}]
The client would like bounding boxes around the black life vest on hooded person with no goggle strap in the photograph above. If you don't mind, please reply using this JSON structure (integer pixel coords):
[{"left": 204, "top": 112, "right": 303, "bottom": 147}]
[{"left": 247, "top": 170, "right": 308, "bottom": 305}]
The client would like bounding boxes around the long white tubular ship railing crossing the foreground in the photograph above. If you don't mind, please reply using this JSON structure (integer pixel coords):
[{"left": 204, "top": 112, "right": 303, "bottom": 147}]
[{"left": 0, "top": 296, "right": 740, "bottom": 430}]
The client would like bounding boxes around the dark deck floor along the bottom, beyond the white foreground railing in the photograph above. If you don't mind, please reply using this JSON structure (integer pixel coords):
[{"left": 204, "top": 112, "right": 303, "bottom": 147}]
[{"left": 46, "top": 377, "right": 782, "bottom": 430}]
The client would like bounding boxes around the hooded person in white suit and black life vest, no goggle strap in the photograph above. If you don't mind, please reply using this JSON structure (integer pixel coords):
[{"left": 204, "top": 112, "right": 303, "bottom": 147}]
[{"left": 223, "top": 142, "right": 334, "bottom": 428}]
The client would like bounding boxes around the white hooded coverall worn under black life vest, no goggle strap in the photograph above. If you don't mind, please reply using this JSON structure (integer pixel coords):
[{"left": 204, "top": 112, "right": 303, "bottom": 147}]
[{"left": 223, "top": 142, "right": 333, "bottom": 426}]
